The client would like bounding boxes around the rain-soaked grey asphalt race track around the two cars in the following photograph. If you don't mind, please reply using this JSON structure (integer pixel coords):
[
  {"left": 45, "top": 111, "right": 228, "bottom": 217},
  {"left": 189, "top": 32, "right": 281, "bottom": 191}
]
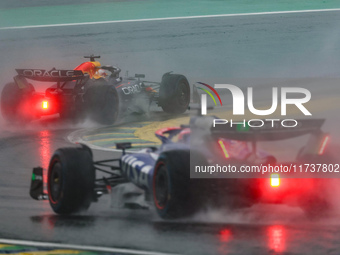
[{"left": 0, "top": 1, "right": 340, "bottom": 254}]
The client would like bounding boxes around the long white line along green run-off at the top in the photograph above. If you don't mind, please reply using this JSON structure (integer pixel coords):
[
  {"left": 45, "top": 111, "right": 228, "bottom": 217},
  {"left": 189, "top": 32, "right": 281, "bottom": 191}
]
[{"left": 0, "top": 8, "right": 340, "bottom": 30}]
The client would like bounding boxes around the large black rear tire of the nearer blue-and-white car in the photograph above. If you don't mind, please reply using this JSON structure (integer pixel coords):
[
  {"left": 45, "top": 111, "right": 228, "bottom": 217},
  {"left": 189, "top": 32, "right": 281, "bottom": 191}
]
[{"left": 152, "top": 151, "right": 202, "bottom": 219}]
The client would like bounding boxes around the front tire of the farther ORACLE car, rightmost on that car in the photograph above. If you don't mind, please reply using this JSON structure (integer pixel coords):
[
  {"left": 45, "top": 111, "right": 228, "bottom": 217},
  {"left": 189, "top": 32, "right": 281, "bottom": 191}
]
[{"left": 159, "top": 73, "right": 190, "bottom": 114}]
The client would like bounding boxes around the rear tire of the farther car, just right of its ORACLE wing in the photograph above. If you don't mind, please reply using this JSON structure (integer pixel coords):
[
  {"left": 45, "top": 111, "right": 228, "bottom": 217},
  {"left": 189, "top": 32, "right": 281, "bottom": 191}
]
[{"left": 84, "top": 84, "right": 119, "bottom": 125}]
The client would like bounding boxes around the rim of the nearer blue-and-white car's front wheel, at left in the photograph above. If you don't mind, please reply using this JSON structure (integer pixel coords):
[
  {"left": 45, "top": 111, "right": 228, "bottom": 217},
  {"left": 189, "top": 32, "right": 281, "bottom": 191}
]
[{"left": 48, "top": 161, "right": 62, "bottom": 204}]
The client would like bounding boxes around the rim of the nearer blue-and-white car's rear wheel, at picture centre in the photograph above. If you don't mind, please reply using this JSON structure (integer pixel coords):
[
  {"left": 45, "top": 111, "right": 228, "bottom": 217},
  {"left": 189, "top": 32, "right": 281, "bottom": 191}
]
[{"left": 153, "top": 164, "right": 169, "bottom": 209}]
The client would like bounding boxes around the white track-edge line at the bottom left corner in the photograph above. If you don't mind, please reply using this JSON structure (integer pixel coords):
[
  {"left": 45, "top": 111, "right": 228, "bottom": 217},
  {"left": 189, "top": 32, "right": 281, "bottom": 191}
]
[{"left": 0, "top": 239, "right": 181, "bottom": 255}]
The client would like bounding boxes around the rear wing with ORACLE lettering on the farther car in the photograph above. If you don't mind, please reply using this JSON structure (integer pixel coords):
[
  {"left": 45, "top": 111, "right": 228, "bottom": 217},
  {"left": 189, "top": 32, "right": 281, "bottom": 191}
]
[{"left": 15, "top": 69, "right": 87, "bottom": 82}]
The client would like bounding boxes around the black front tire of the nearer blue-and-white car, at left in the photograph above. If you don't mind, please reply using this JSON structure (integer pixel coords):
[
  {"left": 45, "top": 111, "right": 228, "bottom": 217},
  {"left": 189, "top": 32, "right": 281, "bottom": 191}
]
[{"left": 47, "top": 148, "right": 95, "bottom": 214}]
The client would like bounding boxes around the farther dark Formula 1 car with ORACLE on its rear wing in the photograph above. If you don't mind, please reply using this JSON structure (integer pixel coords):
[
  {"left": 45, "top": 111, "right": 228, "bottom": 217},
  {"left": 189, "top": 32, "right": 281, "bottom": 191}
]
[{"left": 1, "top": 55, "right": 190, "bottom": 124}]
